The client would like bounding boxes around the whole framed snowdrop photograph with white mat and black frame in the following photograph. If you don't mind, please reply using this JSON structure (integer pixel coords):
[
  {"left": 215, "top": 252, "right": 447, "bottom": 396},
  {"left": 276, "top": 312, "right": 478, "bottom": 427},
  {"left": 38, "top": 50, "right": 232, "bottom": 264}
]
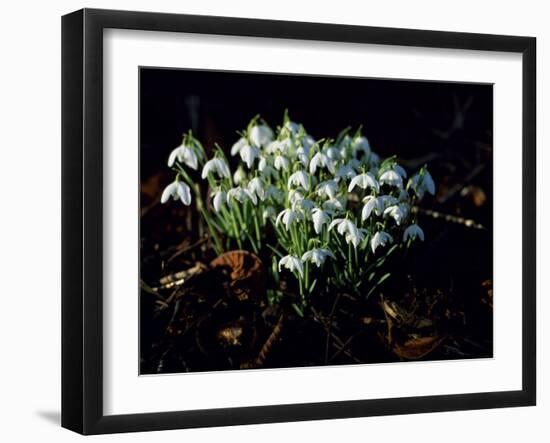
[{"left": 62, "top": 9, "right": 536, "bottom": 434}]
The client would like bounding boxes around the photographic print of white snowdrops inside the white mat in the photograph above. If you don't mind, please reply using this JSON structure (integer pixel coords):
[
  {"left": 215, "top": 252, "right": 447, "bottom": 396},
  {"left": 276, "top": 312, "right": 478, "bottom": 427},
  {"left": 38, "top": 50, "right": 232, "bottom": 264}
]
[{"left": 139, "top": 67, "right": 496, "bottom": 375}]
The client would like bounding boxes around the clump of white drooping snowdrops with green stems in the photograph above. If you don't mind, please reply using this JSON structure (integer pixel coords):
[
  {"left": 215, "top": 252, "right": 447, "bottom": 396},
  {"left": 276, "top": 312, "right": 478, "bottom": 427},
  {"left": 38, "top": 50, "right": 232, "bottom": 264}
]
[{"left": 161, "top": 113, "right": 435, "bottom": 311}]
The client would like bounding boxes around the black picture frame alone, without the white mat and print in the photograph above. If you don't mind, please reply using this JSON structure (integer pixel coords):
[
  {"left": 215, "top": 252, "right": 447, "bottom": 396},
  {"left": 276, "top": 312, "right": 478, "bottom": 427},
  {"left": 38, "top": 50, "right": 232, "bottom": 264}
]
[{"left": 62, "top": 9, "right": 536, "bottom": 434}]
